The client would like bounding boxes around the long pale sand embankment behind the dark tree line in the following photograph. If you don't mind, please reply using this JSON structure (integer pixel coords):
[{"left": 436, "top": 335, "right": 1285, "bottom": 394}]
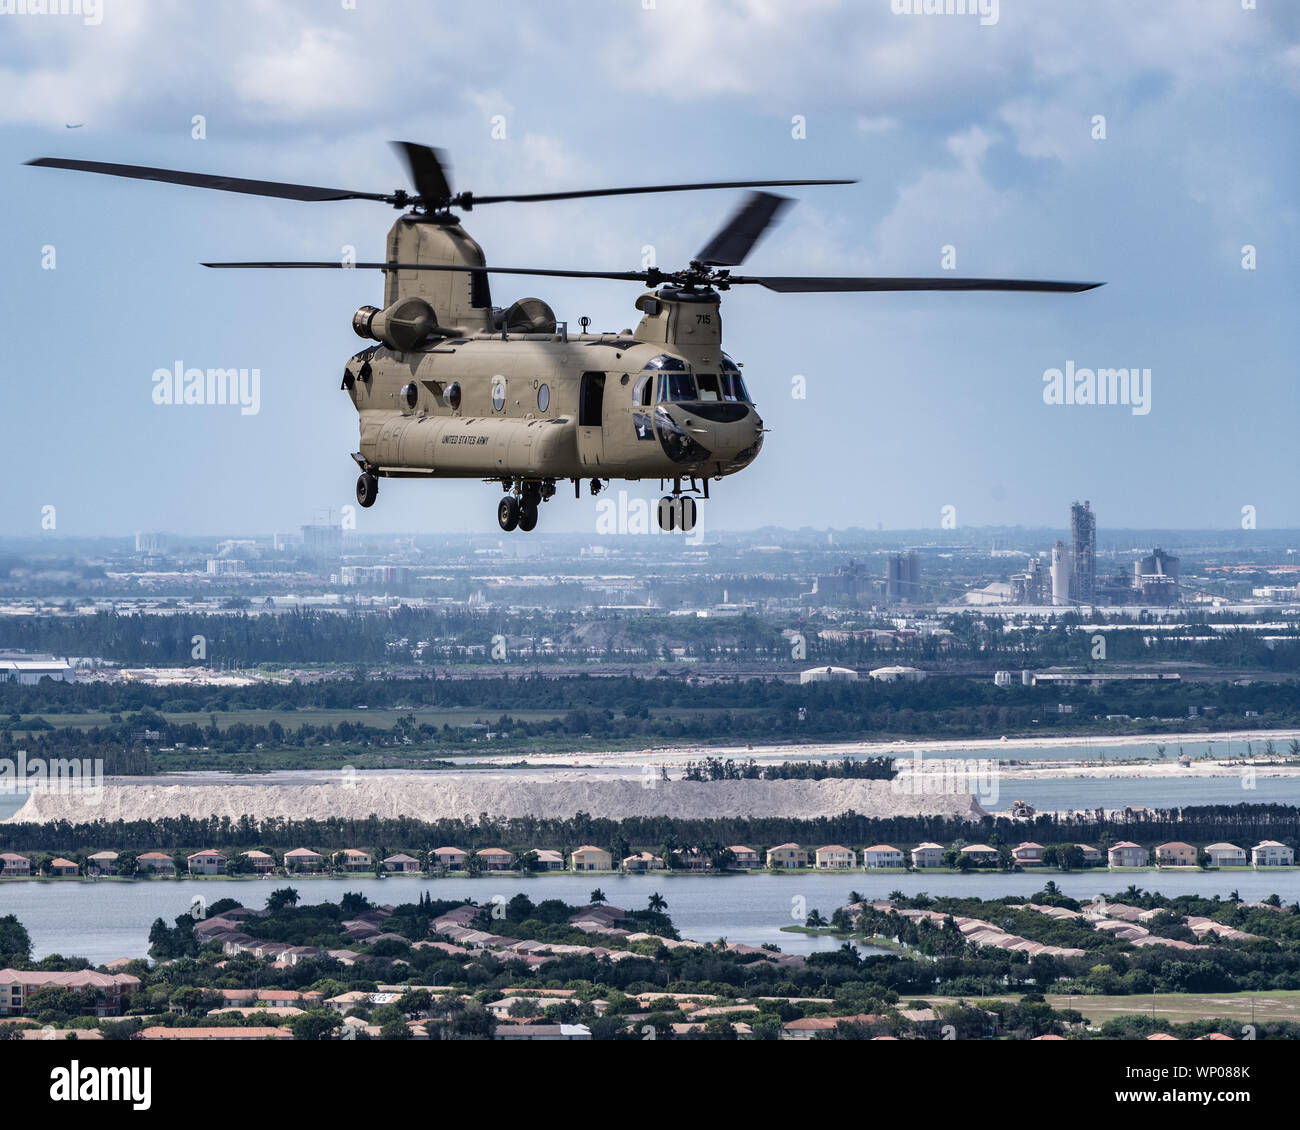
[{"left": 9, "top": 772, "right": 974, "bottom": 823}]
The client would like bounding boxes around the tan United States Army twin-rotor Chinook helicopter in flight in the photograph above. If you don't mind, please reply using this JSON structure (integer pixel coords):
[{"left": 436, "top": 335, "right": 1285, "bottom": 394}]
[{"left": 29, "top": 142, "right": 1101, "bottom": 532}]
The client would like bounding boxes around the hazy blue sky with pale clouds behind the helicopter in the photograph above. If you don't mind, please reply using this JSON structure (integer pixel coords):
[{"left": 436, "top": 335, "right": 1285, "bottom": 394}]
[{"left": 0, "top": 0, "right": 1300, "bottom": 536}]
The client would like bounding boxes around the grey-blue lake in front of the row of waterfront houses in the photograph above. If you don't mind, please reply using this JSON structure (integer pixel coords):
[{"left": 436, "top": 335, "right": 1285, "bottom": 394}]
[{"left": 0, "top": 871, "right": 1300, "bottom": 964}]
